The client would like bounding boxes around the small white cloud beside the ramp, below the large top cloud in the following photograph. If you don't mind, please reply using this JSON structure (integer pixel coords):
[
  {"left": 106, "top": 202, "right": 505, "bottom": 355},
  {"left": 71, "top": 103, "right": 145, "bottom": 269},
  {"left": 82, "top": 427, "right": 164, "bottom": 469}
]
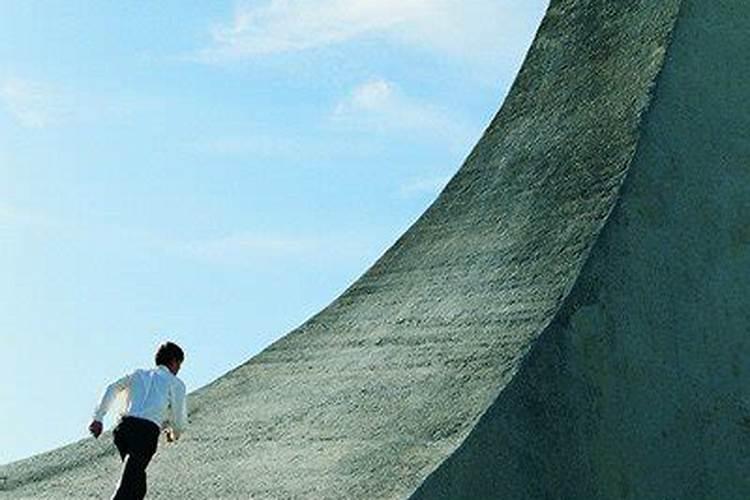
[{"left": 333, "top": 78, "right": 476, "bottom": 149}]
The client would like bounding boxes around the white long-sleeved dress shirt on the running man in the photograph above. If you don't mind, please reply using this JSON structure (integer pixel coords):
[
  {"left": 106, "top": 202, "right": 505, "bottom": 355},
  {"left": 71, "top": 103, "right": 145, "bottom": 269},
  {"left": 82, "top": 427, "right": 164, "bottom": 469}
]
[{"left": 94, "top": 365, "right": 187, "bottom": 438}]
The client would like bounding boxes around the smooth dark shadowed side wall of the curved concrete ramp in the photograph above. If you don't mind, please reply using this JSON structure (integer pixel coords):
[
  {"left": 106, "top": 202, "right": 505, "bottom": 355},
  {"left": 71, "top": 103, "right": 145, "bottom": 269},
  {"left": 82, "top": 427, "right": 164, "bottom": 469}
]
[{"left": 412, "top": 0, "right": 750, "bottom": 500}]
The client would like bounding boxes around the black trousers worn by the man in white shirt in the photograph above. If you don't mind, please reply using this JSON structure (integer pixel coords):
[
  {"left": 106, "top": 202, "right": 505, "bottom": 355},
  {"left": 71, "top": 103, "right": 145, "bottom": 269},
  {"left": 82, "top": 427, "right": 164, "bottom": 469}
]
[{"left": 112, "top": 417, "right": 160, "bottom": 500}]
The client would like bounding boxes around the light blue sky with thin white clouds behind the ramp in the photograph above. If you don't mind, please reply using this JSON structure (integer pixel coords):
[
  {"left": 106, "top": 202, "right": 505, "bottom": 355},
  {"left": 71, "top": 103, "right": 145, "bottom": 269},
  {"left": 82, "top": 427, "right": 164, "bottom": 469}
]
[{"left": 0, "top": 0, "right": 547, "bottom": 463}]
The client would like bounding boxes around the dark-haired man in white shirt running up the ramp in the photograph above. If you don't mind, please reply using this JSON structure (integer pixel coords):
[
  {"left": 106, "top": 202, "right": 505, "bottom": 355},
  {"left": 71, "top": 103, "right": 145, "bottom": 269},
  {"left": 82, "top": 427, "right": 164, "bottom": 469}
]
[{"left": 89, "top": 342, "right": 187, "bottom": 500}]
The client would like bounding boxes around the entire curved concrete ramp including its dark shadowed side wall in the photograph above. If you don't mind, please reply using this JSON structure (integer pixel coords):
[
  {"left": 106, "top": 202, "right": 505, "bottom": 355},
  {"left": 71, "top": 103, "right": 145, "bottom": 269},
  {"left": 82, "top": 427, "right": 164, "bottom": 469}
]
[{"left": 0, "top": 0, "right": 750, "bottom": 499}]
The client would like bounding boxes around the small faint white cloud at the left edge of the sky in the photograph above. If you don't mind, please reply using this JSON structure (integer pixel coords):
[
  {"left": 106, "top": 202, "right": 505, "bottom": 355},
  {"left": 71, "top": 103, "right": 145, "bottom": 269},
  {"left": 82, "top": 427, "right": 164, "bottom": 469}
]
[{"left": 0, "top": 78, "right": 70, "bottom": 128}]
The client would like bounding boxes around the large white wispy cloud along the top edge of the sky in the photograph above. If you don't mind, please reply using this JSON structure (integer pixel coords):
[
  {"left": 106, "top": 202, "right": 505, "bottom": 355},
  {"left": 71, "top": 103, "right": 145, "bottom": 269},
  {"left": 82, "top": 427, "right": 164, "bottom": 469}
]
[{"left": 196, "top": 0, "right": 547, "bottom": 63}]
